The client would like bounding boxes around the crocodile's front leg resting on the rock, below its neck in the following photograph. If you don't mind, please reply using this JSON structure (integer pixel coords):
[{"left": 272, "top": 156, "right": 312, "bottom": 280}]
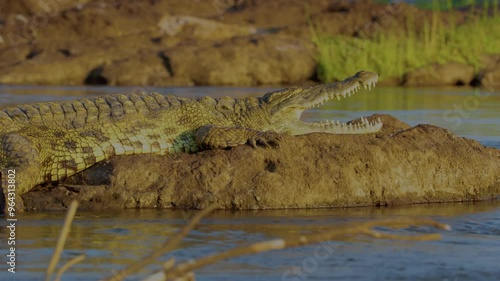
[{"left": 195, "top": 125, "right": 281, "bottom": 149}]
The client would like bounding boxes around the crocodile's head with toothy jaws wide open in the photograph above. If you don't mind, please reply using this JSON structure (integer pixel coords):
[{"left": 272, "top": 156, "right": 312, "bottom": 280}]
[{"left": 262, "top": 71, "right": 382, "bottom": 135}]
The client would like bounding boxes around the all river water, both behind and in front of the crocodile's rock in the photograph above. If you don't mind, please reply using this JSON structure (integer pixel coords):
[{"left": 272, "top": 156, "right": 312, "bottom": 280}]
[{"left": 0, "top": 86, "right": 500, "bottom": 281}]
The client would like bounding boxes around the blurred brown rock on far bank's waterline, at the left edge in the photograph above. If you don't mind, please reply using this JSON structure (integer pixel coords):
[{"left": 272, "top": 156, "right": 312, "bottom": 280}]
[{"left": 0, "top": 34, "right": 164, "bottom": 86}]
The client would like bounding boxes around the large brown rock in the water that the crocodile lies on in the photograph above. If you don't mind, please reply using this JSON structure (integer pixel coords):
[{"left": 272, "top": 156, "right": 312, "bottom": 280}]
[{"left": 23, "top": 116, "right": 500, "bottom": 210}]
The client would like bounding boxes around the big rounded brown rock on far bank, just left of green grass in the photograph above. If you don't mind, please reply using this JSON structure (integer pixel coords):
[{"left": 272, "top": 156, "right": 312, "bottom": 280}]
[{"left": 165, "top": 35, "right": 316, "bottom": 86}]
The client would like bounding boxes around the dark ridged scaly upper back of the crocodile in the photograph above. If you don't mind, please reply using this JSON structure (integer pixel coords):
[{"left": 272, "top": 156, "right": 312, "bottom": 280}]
[{"left": 0, "top": 93, "right": 188, "bottom": 133}]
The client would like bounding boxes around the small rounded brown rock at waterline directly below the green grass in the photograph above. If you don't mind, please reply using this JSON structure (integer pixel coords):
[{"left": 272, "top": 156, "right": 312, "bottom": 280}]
[{"left": 403, "top": 63, "right": 475, "bottom": 86}]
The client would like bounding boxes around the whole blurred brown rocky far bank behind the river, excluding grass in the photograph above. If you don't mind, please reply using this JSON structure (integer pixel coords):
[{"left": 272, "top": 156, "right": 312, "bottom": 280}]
[{"left": 0, "top": 0, "right": 500, "bottom": 87}]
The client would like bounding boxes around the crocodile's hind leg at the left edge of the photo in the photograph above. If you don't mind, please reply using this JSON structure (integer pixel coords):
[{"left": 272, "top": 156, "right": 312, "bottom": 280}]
[{"left": 0, "top": 133, "right": 42, "bottom": 212}]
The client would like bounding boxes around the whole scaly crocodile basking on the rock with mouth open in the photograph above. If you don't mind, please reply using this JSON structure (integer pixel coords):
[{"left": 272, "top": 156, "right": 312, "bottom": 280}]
[{"left": 0, "top": 71, "right": 382, "bottom": 209}]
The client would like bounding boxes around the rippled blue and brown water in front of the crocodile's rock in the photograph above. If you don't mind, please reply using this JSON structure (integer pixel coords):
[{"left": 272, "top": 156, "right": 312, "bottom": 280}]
[{"left": 7, "top": 202, "right": 500, "bottom": 280}]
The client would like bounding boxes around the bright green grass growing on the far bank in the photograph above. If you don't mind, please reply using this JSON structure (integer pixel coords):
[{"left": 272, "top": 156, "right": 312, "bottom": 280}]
[{"left": 311, "top": 0, "right": 500, "bottom": 82}]
